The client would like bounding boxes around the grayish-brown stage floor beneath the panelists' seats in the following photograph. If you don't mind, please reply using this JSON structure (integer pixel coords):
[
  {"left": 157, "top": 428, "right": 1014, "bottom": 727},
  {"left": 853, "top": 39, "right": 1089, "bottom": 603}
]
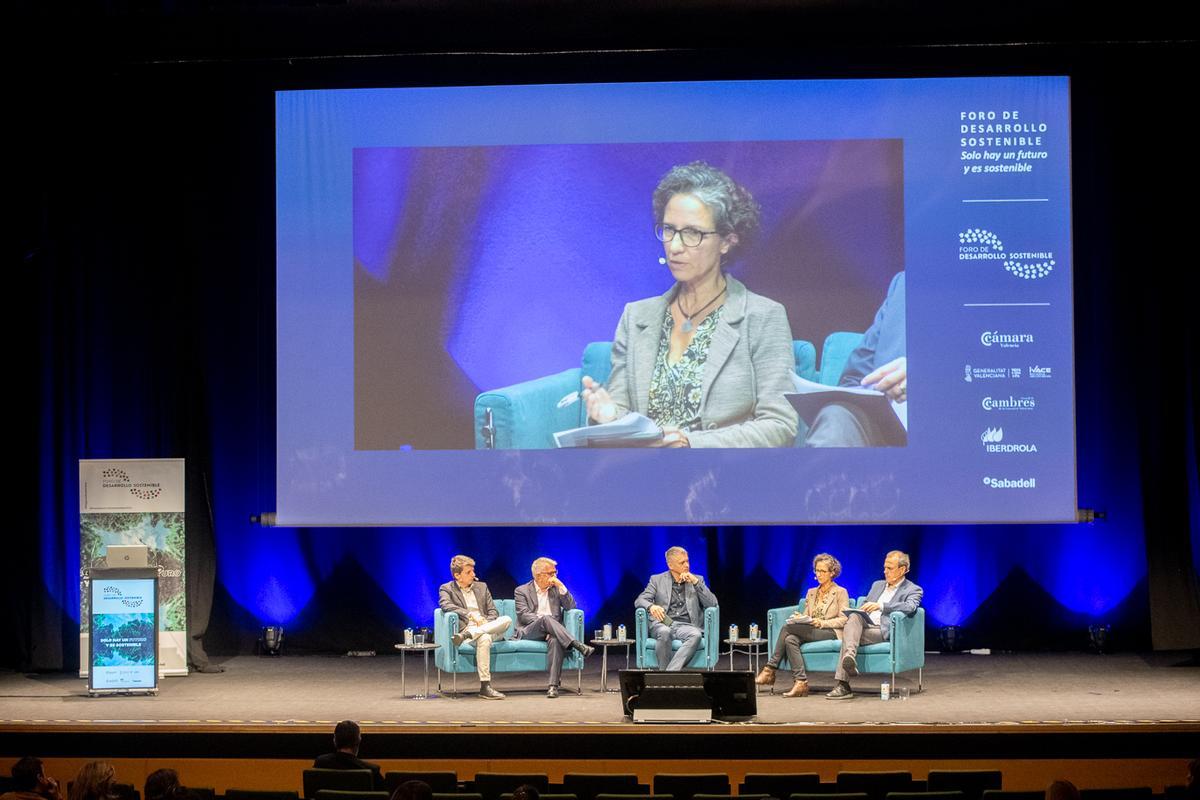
[{"left": 0, "top": 654, "right": 1200, "bottom": 730}]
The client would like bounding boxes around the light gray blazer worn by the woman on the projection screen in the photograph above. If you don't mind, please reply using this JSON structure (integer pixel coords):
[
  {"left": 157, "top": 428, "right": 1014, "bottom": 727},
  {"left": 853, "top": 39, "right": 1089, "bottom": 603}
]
[{"left": 607, "top": 276, "right": 797, "bottom": 447}]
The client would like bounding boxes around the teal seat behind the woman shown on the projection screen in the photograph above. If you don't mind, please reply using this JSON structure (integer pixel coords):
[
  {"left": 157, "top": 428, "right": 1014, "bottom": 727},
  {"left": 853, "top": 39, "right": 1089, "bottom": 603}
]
[{"left": 474, "top": 331, "right": 863, "bottom": 450}]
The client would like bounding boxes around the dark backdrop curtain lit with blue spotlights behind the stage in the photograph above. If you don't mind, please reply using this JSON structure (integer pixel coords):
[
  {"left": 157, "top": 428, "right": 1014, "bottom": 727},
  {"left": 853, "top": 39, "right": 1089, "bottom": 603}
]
[{"left": 7, "top": 2, "right": 1200, "bottom": 669}]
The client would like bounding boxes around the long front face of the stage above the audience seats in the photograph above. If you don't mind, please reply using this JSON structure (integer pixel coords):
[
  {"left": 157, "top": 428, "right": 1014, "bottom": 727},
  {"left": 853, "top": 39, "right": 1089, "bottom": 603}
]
[{"left": 0, "top": 720, "right": 1200, "bottom": 771}]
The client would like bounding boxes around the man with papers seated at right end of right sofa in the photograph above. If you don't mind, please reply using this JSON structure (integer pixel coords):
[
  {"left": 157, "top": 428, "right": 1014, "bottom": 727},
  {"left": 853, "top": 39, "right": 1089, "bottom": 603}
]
[{"left": 826, "top": 551, "right": 925, "bottom": 700}]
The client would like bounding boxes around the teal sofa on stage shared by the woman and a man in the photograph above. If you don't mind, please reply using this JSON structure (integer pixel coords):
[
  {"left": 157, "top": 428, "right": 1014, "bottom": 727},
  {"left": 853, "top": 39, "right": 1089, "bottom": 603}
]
[{"left": 767, "top": 596, "right": 925, "bottom": 692}]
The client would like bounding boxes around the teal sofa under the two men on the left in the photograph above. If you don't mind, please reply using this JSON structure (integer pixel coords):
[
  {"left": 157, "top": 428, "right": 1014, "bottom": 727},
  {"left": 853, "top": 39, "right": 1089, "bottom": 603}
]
[{"left": 433, "top": 600, "right": 586, "bottom": 696}]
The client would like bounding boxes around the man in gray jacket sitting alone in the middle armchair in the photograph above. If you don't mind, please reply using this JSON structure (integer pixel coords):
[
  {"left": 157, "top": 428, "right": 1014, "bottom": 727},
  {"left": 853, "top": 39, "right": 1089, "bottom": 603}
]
[{"left": 634, "top": 547, "right": 716, "bottom": 672}]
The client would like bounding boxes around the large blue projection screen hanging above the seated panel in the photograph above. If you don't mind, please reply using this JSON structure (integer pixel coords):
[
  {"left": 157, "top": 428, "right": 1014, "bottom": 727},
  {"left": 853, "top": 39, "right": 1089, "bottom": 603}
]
[{"left": 276, "top": 77, "right": 1075, "bottom": 525}]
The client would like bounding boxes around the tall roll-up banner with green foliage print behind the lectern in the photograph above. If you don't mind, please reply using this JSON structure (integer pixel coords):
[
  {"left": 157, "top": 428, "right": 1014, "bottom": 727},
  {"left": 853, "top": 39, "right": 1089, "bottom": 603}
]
[{"left": 79, "top": 458, "right": 187, "bottom": 687}]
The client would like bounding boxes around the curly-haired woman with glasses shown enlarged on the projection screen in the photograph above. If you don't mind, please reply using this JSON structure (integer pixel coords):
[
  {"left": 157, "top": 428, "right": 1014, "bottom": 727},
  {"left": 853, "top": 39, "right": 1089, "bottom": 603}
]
[{"left": 583, "top": 162, "right": 797, "bottom": 447}]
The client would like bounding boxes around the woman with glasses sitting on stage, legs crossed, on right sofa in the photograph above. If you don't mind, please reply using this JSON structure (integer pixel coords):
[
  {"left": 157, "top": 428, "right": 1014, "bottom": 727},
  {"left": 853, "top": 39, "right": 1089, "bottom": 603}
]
[{"left": 754, "top": 553, "right": 850, "bottom": 697}]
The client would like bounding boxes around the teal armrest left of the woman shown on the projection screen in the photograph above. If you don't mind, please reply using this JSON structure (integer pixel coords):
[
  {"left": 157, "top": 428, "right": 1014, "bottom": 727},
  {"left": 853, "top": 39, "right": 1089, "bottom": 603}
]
[{"left": 474, "top": 367, "right": 583, "bottom": 450}]
